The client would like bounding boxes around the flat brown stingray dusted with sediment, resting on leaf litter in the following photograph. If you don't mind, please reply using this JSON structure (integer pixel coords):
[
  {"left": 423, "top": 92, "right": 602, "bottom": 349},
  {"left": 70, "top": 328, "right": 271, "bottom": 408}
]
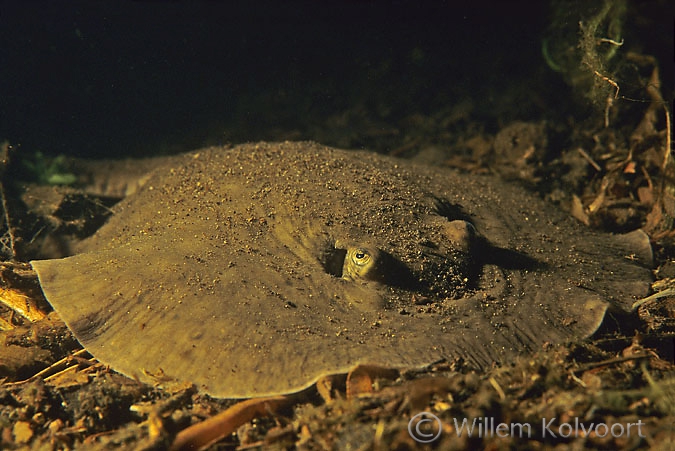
[{"left": 32, "top": 143, "right": 650, "bottom": 398}]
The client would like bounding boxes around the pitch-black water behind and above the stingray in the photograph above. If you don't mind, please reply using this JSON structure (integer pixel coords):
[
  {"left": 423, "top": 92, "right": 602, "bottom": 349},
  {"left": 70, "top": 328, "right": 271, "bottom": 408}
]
[{"left": 0, "top": 0, "right": 672, "bottom": 157}]
